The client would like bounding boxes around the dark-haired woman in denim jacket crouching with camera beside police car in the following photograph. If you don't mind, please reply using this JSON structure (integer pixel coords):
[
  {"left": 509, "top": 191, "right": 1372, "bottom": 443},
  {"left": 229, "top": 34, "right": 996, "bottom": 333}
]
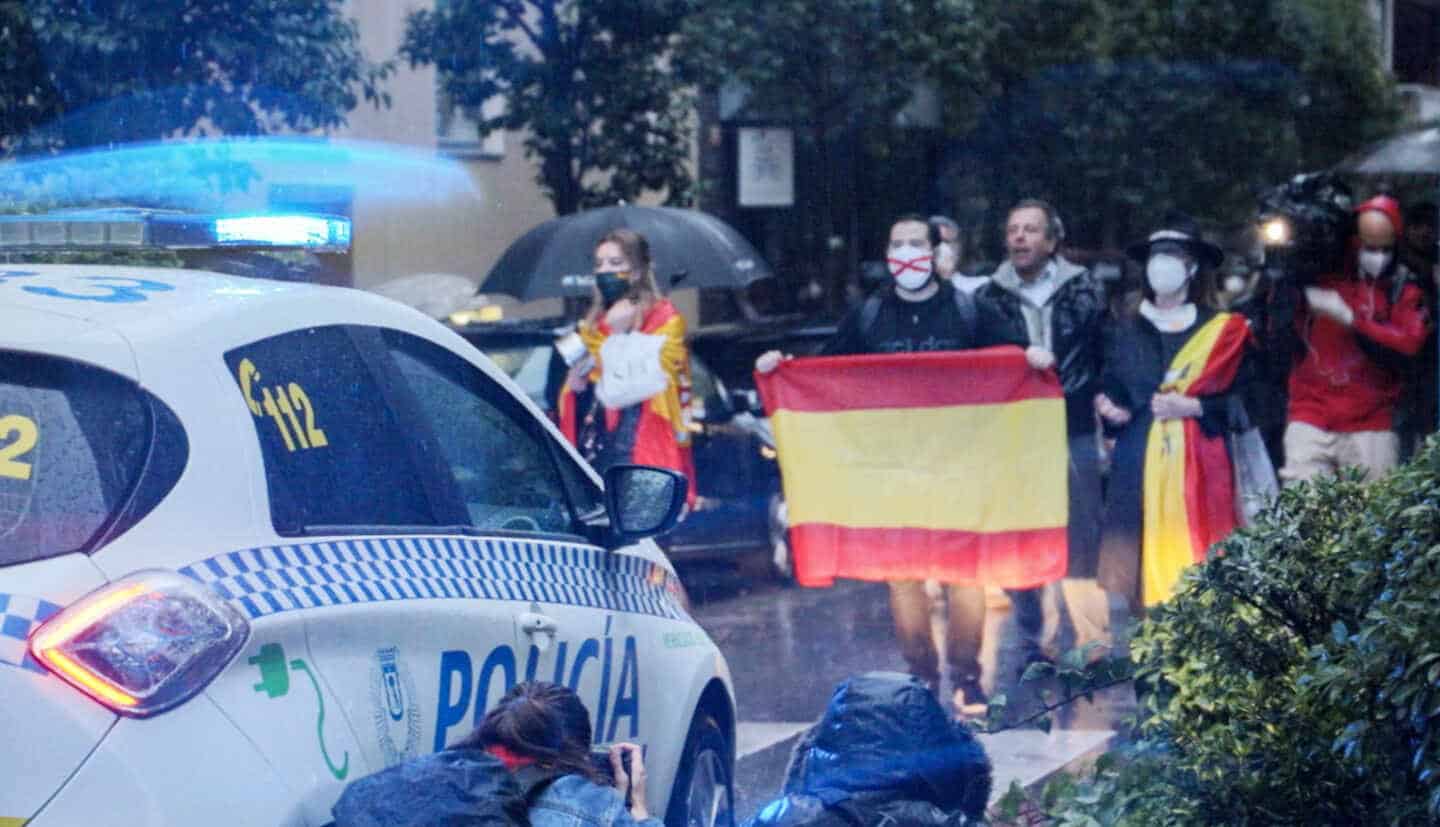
[{"left": 451, "top": 681, "right": 662, "bottom": 827}]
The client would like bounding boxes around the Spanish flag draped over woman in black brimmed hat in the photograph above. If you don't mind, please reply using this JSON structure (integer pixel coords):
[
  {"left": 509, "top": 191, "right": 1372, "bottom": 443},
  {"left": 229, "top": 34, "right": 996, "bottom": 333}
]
[{"left": 1140, "top": 313, "right": 1250, "bottom": 607}]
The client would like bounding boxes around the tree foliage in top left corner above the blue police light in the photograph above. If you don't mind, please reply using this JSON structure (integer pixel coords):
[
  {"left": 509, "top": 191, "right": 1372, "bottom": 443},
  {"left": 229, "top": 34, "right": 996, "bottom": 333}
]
[{"left": 0, "top": 0, "right": 389, "bottom": 156}]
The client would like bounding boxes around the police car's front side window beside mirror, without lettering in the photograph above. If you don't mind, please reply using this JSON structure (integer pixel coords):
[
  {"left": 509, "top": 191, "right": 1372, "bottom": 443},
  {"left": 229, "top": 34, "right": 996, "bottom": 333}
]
[{"left": 386, "top": 331, "right": 587, "bottom": 533}]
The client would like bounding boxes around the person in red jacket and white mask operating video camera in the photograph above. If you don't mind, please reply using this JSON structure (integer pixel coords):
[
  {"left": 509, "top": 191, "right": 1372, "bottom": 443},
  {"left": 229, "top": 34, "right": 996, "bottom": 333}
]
[{"left": 1280, "top": 196, "right": 1430, "bottom": 481}]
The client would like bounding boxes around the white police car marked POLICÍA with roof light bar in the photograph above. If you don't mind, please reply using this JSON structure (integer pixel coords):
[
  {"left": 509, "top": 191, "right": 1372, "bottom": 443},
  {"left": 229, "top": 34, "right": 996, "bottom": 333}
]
[{"left": 0, "top": 211, "right": 734, "bottom": 827}]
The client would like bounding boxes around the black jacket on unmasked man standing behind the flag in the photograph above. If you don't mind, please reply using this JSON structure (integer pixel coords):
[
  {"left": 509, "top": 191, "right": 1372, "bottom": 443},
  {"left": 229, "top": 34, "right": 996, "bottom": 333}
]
[{"left": 975, "top": 258, "right": 1109, "bottom": 437}]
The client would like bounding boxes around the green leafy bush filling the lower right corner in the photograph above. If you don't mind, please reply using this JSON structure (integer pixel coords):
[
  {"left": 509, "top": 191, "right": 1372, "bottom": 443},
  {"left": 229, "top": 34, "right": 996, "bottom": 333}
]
[{"left": 1045, "top": 439, "right": 1440, "bottom": 827}]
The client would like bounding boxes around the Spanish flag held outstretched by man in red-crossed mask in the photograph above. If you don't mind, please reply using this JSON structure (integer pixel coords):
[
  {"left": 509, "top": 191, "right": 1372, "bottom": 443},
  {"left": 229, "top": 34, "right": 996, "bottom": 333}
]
[{"left": 756, "top": 347, "right": 1068, "bottom": 588}]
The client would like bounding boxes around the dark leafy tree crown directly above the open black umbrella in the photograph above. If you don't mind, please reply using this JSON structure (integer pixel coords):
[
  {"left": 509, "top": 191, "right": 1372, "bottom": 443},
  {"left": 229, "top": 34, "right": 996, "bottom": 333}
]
[{"left": 400, "top": 0, "right": 694, "bottom": 215}]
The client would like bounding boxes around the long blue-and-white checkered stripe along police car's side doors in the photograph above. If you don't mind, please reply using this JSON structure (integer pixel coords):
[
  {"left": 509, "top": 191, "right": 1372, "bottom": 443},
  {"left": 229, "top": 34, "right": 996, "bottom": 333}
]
[{"left": 180, "top": 537, "right": 685, "bottom": 620}]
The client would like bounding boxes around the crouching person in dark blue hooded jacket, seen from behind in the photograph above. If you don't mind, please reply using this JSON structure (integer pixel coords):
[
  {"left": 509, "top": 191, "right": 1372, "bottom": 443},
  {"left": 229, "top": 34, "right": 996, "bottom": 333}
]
[{"left": 746, "top": 671, "right": 992, "bottom": 827}]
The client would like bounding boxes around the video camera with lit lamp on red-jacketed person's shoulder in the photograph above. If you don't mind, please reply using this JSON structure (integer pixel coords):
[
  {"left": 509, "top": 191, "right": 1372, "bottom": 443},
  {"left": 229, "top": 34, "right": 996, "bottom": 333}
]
[{"left": 1259, "top": 173, "right": 1355, "bottom": 287}]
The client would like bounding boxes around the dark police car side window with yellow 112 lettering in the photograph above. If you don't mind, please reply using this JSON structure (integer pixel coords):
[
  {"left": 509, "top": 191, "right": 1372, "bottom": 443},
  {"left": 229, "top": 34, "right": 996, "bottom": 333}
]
[{"left": 225, "top": 327, "right": 438, "bottom": 535}]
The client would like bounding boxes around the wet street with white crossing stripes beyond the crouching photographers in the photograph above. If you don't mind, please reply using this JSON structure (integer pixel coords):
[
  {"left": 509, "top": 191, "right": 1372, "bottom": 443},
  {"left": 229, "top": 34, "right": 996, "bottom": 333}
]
[{"left": 681, "top": 568, "right": 1133, "bottom": 823}]
